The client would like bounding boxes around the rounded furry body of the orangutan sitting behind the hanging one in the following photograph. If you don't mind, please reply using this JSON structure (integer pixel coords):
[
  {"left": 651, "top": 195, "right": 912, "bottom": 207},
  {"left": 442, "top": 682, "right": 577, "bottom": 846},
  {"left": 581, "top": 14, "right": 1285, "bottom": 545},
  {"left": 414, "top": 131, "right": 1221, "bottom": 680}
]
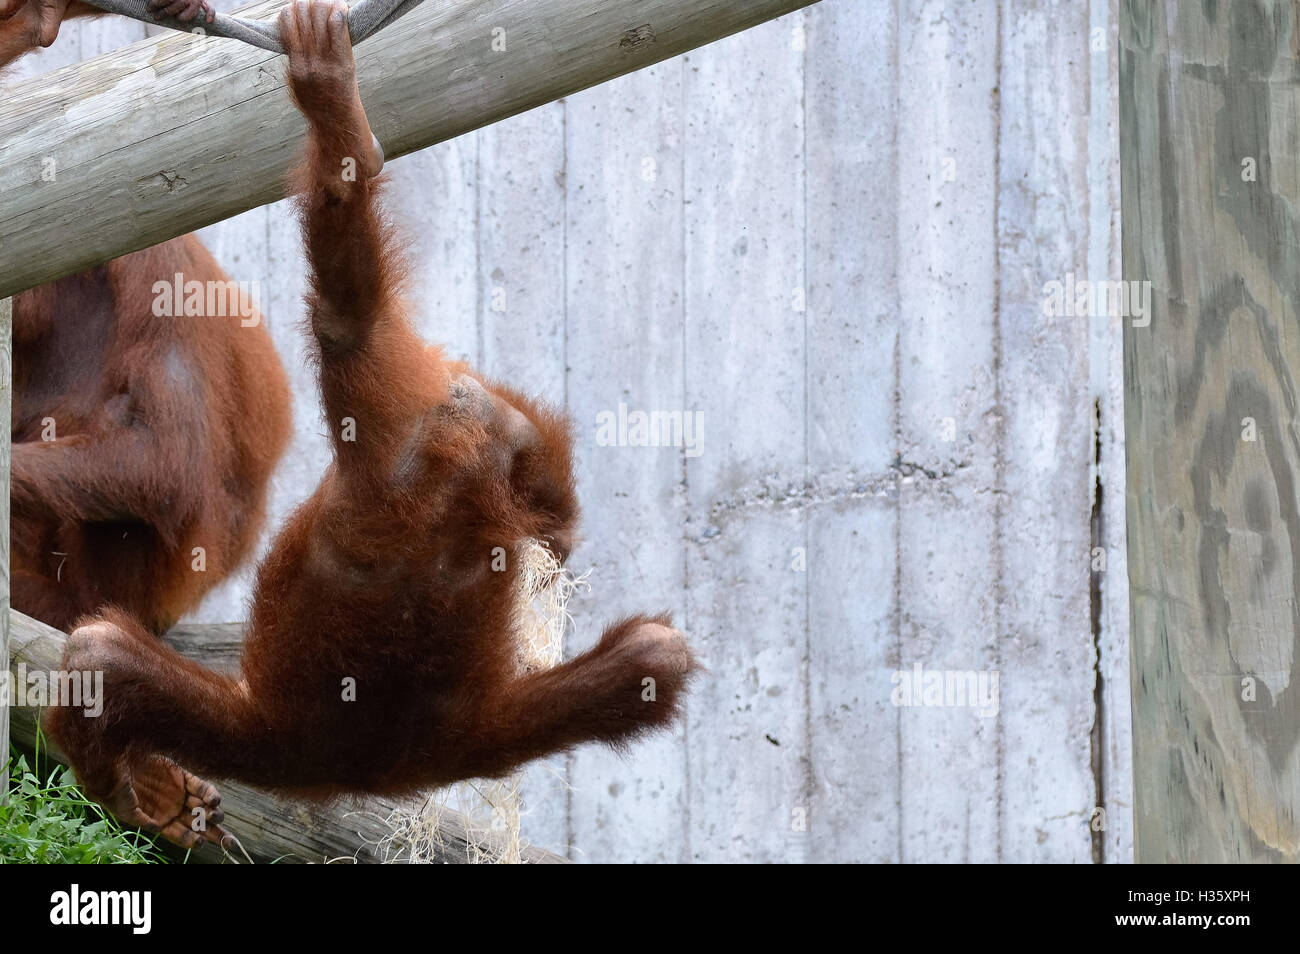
[{"left": 10, "top": 235, "right": 290, "bottom": 630}]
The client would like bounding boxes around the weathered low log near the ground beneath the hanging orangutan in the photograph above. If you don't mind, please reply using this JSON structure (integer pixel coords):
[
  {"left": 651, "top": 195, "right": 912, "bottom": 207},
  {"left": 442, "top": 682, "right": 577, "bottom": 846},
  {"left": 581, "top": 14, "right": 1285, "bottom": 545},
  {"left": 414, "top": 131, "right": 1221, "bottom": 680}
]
[{"left": 8, "top": 611, "right": 567, "bottom": 864}]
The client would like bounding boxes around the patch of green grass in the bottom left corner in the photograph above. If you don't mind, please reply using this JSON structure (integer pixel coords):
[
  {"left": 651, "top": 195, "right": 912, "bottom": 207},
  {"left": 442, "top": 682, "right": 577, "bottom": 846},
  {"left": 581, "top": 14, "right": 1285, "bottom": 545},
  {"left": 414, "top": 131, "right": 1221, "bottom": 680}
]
[{"left": 0, "top": 740, "right": 168, "bottom": 864}]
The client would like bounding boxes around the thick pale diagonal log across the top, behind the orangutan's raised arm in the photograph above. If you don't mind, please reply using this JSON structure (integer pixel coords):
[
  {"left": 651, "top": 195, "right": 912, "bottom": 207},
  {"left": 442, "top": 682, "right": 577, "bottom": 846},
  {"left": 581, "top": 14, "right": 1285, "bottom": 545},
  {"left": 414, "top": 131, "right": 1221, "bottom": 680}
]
[{"left": 0, "top": 0, "right": 814, "bottom": 296}]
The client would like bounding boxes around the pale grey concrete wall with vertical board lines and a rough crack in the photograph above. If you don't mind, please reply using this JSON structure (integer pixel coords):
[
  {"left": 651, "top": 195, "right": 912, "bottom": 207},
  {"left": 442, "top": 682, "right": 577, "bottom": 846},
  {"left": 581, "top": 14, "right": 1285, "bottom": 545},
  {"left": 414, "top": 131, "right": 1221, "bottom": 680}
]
[{"left": 15, "top": 0, "right": 1132, "bottom": 862}]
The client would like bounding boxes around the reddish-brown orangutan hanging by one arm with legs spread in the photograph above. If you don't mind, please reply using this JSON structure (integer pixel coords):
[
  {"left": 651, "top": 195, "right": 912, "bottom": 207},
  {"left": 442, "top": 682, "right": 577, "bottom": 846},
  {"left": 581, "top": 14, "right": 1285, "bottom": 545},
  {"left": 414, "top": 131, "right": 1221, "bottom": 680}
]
[{"left": 47, "top": 0, "right": 697, "bottom": 846}]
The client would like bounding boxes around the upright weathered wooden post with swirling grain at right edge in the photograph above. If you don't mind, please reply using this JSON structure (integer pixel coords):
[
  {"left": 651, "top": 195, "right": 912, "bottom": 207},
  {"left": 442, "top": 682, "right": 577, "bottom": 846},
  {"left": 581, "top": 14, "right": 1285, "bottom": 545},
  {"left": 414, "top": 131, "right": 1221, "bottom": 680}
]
[{"left": 1119, "top": 0, "right": 1300, "bottom": 863}]
